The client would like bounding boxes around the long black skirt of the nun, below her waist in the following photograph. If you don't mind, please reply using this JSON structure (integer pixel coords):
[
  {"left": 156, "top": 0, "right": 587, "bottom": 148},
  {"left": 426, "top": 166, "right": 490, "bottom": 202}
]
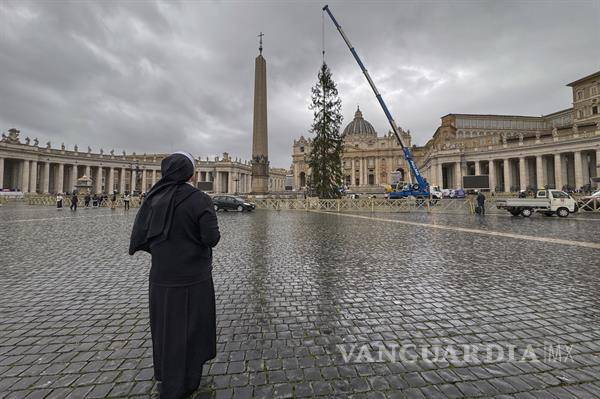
[{"left": 150, "top": 278, "right": 217, "bottom": 399}]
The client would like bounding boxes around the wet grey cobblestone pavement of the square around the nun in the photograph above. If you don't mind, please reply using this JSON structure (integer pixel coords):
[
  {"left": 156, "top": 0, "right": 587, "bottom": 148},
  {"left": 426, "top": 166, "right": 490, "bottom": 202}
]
[{"left": 0, "top": 205, "right": 600, "bottom": 398}]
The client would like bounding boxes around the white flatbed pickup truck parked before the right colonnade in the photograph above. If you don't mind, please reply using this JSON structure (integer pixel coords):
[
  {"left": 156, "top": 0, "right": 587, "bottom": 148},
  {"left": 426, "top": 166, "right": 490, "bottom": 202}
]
[{"left": 496, "top": 189, "right": 577, "bottom": 218}]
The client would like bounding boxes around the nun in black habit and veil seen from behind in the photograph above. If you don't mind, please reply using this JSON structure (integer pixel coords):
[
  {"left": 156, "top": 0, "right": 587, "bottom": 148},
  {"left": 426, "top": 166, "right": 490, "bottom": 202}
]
[{"left": 129, "top": 152, "right": 220, "bottom": 399}]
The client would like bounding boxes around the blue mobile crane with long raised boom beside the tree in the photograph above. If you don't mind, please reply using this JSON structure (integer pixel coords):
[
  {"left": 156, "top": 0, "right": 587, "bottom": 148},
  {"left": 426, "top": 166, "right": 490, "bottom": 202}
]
[{"left": 323, "top": 5, "right": 429, "bottom": 198}]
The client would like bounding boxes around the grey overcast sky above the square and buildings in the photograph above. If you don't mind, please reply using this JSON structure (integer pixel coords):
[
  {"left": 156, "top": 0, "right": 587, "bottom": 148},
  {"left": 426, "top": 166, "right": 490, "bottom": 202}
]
[{"left": 0, "top": 0, "right": 600, "bottom": 168}]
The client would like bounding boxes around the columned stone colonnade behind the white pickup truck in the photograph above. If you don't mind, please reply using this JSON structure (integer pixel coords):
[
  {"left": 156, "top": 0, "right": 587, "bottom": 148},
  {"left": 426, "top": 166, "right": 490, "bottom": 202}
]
[{"left": 427, "top": 149, "right": 600, "bottom": 192}]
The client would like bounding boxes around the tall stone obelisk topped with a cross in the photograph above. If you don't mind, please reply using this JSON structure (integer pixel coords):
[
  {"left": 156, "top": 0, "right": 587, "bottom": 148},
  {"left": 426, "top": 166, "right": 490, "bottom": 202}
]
[{"left": 252, "top": 32, "right": 269, "bottom": 195}]
